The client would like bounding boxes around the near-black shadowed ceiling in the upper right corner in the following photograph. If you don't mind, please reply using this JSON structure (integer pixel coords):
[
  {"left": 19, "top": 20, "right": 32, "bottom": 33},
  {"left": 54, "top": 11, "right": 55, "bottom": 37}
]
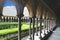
[{"left": 44, "top": 0, "right": 60, "bottom": 19}]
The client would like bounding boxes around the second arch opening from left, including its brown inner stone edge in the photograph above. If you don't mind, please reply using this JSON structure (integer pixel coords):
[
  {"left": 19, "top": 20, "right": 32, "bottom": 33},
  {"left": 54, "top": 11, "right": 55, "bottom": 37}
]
[{"left": 23, "top": 4, "right": 32, "bottom": 22}]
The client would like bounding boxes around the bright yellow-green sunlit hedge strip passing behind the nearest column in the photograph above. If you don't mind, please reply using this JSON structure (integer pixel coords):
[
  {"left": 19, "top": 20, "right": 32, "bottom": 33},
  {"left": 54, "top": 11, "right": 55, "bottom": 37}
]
[{"left": 0, "top": 24, "right": 40, "bottom": 35}]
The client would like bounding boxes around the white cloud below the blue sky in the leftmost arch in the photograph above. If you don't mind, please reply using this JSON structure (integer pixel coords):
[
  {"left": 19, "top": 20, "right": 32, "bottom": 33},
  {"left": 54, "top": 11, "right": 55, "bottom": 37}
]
[{"left": 3, "top": 6, "right": 17, "bottom": 16}]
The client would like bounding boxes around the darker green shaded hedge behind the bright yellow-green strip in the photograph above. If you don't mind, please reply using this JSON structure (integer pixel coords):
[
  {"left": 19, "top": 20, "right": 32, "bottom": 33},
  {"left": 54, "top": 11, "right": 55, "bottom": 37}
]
[{"left": 0, "top": 22, "right": 26, "bottom": 30}]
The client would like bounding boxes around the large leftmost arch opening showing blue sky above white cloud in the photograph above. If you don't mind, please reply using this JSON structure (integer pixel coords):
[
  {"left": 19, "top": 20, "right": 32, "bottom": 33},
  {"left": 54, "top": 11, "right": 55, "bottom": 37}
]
[{"left": 2, "top": 0, "right": 17, "bottom": 16}]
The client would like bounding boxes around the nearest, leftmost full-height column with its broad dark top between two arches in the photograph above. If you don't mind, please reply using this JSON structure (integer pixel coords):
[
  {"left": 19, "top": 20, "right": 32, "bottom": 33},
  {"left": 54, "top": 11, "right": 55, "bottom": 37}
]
[{"left": 16, "top": 0, "right": 24, "bottom": 40}]
